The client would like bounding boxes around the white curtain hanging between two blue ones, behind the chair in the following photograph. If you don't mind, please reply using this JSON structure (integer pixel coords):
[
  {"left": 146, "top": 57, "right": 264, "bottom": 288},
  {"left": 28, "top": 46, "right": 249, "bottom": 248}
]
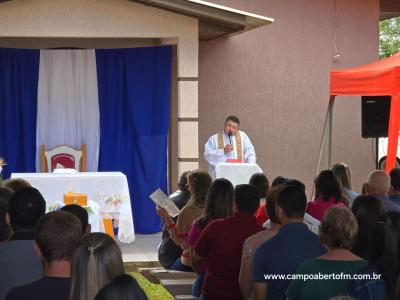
[{"left": 36, "top": 50, "right": 100, "bottom": 171}]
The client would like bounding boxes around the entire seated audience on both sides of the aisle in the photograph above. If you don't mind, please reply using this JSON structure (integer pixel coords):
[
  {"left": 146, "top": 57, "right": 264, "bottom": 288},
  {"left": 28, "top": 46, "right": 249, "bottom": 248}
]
[{"left": 0, "top": 163, "right": 400, "bottom": 300}]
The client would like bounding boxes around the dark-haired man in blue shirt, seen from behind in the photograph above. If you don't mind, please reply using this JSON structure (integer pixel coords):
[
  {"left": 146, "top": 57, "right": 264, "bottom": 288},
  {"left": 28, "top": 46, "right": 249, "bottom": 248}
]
[{"left": 252, "top": 186, "right": 326, "bottom": 300}]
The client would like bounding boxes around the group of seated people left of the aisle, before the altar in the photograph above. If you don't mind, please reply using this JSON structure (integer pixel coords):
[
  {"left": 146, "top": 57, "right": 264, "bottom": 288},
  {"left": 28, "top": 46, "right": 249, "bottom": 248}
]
[{"left": 0, "top": 179, "right": 147, "bottom": 300}]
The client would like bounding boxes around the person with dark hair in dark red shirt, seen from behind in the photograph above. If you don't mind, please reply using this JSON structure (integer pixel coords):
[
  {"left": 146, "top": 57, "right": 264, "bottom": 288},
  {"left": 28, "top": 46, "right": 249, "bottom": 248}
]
[{"left": 192, "top": 184, "right": 263, "bottom": 300}]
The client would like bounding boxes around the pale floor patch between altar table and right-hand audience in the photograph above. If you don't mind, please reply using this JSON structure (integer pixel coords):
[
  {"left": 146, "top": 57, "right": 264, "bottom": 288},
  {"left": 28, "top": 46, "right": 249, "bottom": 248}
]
[{"left": 119, "top": 233, "right": 161, "bottom": 262}]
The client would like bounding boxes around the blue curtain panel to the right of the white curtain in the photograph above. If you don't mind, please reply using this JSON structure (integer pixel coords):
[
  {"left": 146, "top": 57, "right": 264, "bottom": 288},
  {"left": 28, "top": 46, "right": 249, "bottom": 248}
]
[{"left": 96, "top": 46, "right": 172, "bottom": 233}]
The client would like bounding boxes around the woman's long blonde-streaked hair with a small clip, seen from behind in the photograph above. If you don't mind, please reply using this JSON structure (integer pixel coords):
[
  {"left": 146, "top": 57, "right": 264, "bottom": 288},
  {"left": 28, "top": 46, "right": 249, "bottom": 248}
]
[{"left": 69, "top": 232, "right": 125, "bottom": 300}]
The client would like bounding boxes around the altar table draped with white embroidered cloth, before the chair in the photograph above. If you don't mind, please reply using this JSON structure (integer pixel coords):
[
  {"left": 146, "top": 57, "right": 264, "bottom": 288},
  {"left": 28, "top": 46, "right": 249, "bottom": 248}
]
[{"left": 11, "top": 172, "right": 135, "bottom": 243}]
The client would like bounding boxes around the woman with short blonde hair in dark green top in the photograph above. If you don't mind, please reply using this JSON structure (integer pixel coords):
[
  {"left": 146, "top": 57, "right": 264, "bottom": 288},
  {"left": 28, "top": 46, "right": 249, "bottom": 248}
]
[{"left": 286, "top": 206, "right": 367, "bottom": 300}]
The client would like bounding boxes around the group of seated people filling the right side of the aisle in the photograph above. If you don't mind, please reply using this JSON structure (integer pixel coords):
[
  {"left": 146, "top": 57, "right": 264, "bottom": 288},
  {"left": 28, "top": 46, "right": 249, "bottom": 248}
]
[{"left": 157, "top": 168, "right": 400, "bottom": 300}]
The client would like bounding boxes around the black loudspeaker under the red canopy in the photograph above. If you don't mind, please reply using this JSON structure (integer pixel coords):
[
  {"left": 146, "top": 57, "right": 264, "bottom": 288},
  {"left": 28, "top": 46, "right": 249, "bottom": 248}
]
[{"left": 361, "top": 96, "right": 391, "bottom": 138}]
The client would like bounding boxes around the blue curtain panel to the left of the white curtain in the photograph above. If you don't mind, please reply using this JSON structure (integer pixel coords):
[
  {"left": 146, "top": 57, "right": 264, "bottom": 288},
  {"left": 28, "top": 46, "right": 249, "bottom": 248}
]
[{"left": 0, "top": 48, "right": 40, "bottom": 178}]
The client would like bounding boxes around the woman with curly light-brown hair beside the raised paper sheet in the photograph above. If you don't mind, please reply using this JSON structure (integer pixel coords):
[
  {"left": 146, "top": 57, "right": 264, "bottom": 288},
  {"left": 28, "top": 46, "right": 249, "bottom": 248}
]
[{"left": 157, "top": 170, "right": 212, "bottom": 272}]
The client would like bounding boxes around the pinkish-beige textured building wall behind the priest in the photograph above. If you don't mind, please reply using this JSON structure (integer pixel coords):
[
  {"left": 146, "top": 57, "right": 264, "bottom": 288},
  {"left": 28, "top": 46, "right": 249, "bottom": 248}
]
[{"left": 199, "top": 0, "right": 379, "bottom": 194}]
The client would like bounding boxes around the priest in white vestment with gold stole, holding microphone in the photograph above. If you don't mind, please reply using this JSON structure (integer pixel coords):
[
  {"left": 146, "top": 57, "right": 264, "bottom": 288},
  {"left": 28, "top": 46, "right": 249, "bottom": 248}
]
[{"left": 204, "top": 116, "right": 256, "bottom": 178}]
